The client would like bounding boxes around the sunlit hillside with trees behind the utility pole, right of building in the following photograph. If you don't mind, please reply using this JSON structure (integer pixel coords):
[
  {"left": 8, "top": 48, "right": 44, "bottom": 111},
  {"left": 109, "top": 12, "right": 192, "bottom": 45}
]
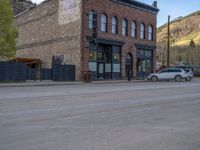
[{"left": 157, "top": 11, "right": 200, "bottom": 65}]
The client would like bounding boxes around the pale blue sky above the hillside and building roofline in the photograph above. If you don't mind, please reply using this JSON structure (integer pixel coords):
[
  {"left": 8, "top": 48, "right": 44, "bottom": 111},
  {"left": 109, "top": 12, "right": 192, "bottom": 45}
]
[{"left": 32, "top": 0, "right": 200, "bottom": 27}]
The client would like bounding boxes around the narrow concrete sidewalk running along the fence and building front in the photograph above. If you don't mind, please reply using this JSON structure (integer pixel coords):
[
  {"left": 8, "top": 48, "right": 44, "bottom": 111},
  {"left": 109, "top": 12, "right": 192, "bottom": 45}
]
[{"left": 0, "top": 80, "right": 146, "bottom": 88}]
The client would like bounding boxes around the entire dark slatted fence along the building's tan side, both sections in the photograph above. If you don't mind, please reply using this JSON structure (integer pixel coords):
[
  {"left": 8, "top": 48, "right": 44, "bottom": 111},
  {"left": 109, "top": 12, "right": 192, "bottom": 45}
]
[{"left": 0, "top": 62, "right": 75, "bottom": 81}]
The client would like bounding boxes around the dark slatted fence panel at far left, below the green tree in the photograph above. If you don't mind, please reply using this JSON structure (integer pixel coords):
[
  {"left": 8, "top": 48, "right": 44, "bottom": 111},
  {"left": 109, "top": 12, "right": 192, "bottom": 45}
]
[{"left": 0, "top": 62, "right": 26, "bottom": 81}]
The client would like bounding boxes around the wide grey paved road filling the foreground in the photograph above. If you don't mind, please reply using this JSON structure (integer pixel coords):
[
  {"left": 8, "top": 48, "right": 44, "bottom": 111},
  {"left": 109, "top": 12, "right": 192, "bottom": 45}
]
[{"left": 0, "top": 80, "right": 200, "bottom": 150}]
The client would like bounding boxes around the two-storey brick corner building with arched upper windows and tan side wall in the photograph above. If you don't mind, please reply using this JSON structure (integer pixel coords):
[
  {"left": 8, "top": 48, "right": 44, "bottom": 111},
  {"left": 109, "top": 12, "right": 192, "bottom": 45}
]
[{"left": 16, "top": 0, "right": 159, "bottom": 80}]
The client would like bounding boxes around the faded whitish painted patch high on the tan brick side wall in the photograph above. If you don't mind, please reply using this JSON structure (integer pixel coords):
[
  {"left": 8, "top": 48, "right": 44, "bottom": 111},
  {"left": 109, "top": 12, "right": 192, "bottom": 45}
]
[{"left": 58, "top": 0, "right": 81, "bottom": 24}]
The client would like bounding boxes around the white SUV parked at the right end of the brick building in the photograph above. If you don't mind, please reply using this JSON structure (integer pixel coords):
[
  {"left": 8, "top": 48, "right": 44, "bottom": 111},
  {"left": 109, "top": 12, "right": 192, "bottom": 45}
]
[{"left": 147, "top": 68, "right": 189, "bottom": 82}]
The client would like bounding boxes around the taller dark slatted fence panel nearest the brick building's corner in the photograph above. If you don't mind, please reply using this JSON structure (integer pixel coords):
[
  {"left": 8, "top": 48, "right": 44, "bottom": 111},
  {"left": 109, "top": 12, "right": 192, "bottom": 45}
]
[{"left": 52, "top": 64, "right": 75, "bottom": 81}]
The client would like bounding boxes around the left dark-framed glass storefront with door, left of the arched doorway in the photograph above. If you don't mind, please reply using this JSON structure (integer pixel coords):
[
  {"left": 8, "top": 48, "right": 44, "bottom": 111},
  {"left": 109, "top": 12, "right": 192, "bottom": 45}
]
[{"left": 88, "top": 42, "right": 121, "bottom": 80}]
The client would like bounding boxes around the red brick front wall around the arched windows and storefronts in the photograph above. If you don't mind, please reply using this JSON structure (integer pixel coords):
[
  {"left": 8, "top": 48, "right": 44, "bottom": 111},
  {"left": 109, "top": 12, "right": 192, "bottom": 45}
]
[{"left": 82, "top": 0, "right": 157, "bottom": 78}]
